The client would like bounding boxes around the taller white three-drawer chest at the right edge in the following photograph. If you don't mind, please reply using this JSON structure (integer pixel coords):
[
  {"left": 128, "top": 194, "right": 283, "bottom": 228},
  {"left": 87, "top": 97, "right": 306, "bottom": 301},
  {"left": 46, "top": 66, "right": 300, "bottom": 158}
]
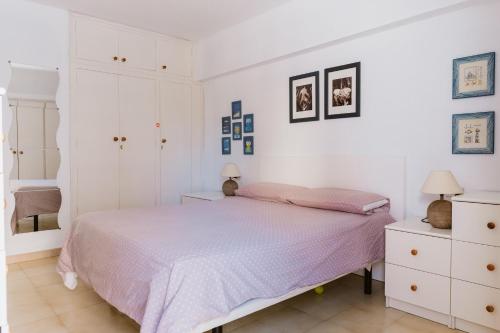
[{"left": 451, "top": 192, "right": 500, "bottom": 332}]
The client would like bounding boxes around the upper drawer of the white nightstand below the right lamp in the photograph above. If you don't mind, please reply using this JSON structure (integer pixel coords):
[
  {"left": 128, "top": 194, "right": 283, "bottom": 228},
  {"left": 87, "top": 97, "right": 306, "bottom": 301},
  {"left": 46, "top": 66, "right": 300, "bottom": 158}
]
[{"left": 385, "top": 230, "right": 451, "bottom": 276}]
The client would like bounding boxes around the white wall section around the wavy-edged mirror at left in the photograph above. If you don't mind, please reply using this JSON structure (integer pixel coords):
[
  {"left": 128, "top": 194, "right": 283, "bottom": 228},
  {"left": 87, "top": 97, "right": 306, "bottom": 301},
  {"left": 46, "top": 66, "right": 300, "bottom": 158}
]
[{"left": 0, "top": 0, "right": 70, "bottom": 255}]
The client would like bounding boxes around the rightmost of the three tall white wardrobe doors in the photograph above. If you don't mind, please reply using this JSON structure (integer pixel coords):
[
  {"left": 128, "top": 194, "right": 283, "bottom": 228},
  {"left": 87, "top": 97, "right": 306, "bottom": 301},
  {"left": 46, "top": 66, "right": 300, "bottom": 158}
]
[{"left": 160, "top": 81, "right": 191, "bottom": 204}]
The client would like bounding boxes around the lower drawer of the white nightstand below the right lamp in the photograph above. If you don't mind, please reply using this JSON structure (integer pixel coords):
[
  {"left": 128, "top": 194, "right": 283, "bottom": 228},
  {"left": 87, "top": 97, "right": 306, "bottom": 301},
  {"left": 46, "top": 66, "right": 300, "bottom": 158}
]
[{"left": 385, "top": 264, "right": 450, "bottom": 314}]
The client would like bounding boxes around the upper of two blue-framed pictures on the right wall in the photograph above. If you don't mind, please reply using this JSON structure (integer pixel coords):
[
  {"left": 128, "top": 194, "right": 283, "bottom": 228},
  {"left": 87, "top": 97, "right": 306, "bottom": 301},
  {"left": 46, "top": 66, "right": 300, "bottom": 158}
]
[{"left": 453, "top": 52, "right": 495, "bottom": 99}]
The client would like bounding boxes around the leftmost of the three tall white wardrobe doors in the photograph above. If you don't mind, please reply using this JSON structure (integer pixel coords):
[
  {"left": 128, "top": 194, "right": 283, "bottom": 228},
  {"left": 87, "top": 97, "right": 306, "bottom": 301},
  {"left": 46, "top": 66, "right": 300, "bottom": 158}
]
[{"left": 73, "top": 70, "right": 120, "bottom": 214}]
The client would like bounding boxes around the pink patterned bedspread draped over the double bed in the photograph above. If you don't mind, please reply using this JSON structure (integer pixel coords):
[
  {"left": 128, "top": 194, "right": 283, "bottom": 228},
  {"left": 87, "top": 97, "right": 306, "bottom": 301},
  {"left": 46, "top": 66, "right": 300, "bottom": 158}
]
[{"left": 58, "top": 197, "right": 393, "bottom": 333}]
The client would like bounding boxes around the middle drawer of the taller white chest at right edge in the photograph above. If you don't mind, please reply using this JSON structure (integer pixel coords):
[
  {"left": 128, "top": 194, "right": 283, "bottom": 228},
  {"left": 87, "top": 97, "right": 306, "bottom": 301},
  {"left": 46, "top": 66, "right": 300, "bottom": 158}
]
[{"left": 451, "top": 240, "right": 500, "bottom": 288}]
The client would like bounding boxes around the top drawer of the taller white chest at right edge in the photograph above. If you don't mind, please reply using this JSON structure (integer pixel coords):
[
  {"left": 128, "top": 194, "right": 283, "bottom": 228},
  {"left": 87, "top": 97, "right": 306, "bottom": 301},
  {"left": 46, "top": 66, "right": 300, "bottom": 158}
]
[{"left": 452, "top": 201, "right": 500, "bottom": 246}]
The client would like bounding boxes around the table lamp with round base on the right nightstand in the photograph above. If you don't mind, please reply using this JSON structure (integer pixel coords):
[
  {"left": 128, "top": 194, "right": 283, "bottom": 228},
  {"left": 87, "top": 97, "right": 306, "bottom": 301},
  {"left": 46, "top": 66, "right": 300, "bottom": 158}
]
[{"left": 422, "top": 170, "right": 464, "bottom": 229}]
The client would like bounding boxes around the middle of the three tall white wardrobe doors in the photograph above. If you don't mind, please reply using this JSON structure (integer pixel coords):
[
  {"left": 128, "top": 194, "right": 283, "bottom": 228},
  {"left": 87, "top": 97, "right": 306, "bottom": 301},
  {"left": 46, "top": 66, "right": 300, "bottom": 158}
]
[{"left": 119, "top": 76, "right": 158, "bottom": 208}]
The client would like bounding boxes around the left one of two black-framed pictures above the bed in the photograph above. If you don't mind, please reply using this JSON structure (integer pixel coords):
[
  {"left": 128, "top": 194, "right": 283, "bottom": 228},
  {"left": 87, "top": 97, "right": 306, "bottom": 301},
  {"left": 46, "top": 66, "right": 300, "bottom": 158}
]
[{"left": 289, "top": 71, "right": 319, "bottom": 124}]
